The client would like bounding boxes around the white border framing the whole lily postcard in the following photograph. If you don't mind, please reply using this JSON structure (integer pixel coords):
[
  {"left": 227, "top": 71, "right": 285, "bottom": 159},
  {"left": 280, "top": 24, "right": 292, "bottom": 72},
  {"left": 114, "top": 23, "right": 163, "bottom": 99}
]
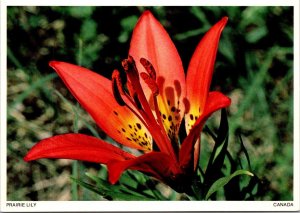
[{"left": 0, "top": 0, "right": 300, "bottom": 212}]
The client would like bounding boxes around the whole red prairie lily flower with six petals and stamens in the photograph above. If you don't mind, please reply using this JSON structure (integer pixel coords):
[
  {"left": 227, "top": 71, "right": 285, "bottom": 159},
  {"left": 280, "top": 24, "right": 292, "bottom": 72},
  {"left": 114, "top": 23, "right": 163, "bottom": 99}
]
[{"left": 24, "top": 11, "right": 230, "bottom": 192}]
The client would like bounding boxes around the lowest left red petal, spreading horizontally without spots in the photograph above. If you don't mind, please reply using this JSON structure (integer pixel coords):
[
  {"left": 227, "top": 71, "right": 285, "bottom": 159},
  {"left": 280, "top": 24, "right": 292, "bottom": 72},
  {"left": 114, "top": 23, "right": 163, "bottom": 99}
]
[{"left": 24, "top": 134, "right": 134, "bottom": 164}]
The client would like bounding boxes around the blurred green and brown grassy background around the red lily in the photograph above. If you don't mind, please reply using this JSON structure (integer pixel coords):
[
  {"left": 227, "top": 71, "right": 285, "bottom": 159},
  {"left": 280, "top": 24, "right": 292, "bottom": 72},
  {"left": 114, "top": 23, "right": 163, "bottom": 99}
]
[{"left": 7, "top": 6, "right": 293, "bottom": 200}]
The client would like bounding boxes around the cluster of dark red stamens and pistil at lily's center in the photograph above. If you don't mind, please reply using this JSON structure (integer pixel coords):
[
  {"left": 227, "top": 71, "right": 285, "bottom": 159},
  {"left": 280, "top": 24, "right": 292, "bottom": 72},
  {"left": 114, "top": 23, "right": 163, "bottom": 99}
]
[{"left": 112, "top": 56, "right": 176, "bottom": 161}]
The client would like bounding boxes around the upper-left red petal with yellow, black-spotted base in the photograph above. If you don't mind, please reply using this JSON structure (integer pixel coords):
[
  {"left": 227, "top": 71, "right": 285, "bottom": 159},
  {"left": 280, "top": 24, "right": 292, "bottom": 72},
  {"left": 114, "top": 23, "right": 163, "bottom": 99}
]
[{"left": 50, "top": 61, "right": 152, "bottom": 150}]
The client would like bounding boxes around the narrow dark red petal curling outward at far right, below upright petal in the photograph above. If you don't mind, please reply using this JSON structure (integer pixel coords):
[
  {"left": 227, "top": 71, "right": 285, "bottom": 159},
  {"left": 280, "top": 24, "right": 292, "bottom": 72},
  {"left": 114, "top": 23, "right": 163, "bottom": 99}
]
[{"left": 179, "top": 92, "right": 231, "bottom": 168}]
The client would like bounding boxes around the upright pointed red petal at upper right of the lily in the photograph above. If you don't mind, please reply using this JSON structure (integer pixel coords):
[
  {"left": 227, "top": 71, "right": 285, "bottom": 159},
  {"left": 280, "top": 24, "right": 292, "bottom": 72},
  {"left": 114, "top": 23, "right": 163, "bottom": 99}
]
[{"left": 185, "top": 17, "right": 228, "bottom": 133}]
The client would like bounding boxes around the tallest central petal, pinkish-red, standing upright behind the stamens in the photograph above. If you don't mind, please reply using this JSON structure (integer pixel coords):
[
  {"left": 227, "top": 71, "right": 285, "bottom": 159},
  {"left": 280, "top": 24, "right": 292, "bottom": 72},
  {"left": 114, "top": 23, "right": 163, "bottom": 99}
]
[{"left": 129, "top": 11, "right": 186, "bottom": 141}]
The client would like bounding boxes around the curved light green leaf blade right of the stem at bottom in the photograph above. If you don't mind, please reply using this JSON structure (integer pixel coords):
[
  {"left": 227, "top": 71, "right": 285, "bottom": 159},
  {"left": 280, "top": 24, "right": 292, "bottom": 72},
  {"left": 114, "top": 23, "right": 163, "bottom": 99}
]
[{"left": 205, "top": 170, "right": 254, "bottom": 200}]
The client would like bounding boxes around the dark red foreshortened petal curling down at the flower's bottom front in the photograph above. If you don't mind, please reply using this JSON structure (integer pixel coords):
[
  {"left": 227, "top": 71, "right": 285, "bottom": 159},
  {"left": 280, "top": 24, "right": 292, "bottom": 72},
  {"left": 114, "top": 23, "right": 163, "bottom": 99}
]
[{"left": 107, "top": 152, "right": 179, "bottom": 184}]
